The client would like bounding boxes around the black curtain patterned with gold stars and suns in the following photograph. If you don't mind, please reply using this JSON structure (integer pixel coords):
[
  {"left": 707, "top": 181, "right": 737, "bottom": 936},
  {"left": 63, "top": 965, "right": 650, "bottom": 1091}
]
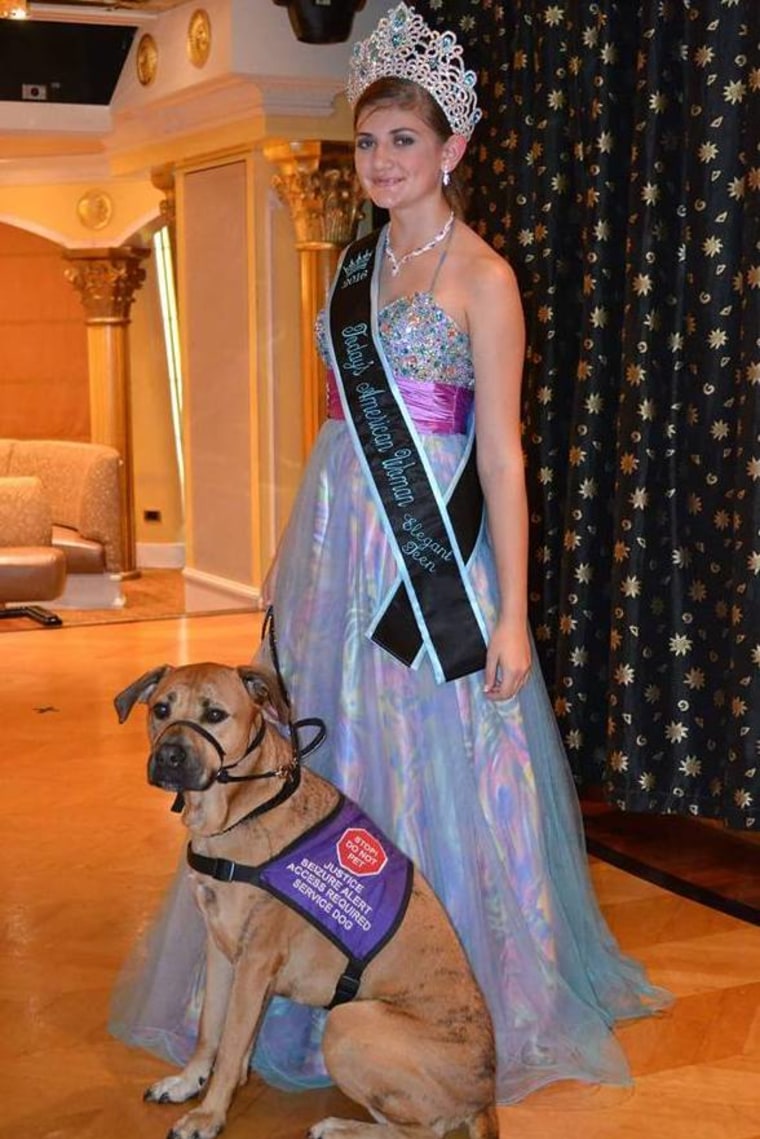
[{"left": 416, "top": 0, "right": 760, "bottom": 828}]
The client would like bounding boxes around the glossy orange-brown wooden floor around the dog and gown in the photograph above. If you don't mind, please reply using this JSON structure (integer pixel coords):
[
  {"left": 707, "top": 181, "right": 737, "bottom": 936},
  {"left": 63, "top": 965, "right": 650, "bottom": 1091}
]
[{"left": 0, "top": 614, "right": 760, "bottom": 1139}]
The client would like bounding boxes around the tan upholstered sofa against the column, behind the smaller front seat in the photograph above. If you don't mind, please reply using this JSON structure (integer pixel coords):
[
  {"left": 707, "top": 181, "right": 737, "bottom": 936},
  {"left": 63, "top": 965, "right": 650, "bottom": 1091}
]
[{"left": 0, "top": 439, "right": 124, "bottom": 608}]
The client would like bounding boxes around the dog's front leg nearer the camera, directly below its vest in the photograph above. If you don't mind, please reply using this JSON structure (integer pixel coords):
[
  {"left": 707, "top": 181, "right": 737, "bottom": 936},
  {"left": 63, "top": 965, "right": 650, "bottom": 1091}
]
[{"left": 169, "top": 956, "right": 271, "bottom": 1139}]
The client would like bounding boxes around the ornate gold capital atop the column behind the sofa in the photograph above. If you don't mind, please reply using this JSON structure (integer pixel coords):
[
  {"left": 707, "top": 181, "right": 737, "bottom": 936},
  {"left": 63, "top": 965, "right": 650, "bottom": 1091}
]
[{"left": 64, "top": 245, "right": 150, "bottom": 325}]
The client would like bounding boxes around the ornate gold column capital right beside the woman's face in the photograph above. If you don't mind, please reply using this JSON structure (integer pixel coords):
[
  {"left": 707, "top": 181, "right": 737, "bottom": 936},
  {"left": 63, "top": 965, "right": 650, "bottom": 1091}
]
[{"left": 263, "top": 139, "right": 363, "bottom": 251}]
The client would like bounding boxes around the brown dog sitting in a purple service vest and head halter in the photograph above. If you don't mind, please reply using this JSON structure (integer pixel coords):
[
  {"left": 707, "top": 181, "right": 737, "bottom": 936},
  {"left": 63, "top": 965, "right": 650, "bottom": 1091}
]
[{"left": 115, "top": 664, "right": 498, "bottom": 1139}]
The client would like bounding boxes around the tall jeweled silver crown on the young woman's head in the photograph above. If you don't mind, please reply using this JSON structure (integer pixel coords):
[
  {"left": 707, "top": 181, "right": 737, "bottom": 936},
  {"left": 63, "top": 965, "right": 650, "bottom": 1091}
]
[{"left": 346, "top": 3, "right": 482, "bottom": 139}]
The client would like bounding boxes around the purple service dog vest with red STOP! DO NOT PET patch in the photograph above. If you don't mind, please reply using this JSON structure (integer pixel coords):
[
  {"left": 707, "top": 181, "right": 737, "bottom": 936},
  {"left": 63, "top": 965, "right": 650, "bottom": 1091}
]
[{"left": 187, "top": 795, "right": 414, "bottom": 1008}]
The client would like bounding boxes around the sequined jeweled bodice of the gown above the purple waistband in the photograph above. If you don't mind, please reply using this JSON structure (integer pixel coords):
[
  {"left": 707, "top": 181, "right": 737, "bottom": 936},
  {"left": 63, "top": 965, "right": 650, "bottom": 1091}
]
[{"left": 317, "top": 293, "right": 475, "bottom": 390}]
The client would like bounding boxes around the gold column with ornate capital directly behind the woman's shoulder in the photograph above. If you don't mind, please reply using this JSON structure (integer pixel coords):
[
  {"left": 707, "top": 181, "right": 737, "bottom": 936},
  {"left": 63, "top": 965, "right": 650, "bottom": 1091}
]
[{"left": 263, "top": 140, "right": 362, "bottom": 457}]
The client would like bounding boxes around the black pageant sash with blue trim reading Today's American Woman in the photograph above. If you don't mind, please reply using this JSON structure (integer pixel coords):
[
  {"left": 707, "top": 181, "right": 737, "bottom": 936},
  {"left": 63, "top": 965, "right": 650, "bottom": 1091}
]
[{"left": 328, "top": 226, "right": 487, "bottom": 682}]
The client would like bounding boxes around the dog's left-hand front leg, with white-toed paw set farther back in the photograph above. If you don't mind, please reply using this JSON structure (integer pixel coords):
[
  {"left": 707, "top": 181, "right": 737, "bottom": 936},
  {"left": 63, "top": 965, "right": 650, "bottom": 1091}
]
[{"left": 145, "top": 935, "right": 235, "bottom": 1104}]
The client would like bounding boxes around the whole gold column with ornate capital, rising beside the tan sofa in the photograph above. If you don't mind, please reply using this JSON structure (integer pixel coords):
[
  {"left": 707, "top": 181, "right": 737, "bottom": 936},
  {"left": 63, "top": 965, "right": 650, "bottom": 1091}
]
[{"left": 64, "top": 246, "right": 150, "bottom": 577}]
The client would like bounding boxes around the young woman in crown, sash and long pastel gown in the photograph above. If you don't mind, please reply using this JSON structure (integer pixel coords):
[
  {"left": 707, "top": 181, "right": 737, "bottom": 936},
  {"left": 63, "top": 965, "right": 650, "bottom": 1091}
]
[{"left": 109, "top": 3, "right": 668, "bottom": 1103}]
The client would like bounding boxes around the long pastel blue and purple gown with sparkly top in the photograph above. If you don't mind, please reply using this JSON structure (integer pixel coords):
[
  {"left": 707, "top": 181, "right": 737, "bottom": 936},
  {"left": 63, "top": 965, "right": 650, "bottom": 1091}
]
[{"left": 111, "top": 264, "right": 669, "bottom": 1104}]
